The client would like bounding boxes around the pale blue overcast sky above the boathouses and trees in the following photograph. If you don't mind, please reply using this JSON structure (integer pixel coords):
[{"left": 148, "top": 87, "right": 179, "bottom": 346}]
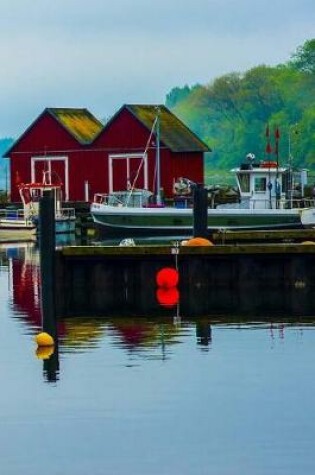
[{"left": 0, "top": 0, "right": 315, "bottom": 138}]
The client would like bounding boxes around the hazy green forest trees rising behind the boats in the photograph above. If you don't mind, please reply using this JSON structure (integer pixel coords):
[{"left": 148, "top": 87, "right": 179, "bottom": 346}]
[{"left": 166, "top": 39, "right": 315, "bottom": 170}]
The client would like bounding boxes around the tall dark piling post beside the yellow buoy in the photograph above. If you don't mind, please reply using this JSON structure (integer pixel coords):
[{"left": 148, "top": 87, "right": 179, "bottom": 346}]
[{"left": 39, "top": 190, "right": 57, "bottom": 341}]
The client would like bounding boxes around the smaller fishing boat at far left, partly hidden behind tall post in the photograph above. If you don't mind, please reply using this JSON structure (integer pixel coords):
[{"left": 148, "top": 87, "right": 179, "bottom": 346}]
[{"left": 0, "top": 172, "right": 75, "bottom": 241}]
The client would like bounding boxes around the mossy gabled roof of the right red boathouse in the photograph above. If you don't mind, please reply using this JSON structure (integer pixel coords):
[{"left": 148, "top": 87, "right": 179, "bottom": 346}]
[{"left": 105, "top": 104, "right": 211, "bottom": 152}]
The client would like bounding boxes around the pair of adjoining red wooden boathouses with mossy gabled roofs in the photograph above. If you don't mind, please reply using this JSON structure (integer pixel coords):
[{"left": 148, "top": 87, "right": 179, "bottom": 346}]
[{"left": 6, "top": 105, "right": 209, "bottom": 201}]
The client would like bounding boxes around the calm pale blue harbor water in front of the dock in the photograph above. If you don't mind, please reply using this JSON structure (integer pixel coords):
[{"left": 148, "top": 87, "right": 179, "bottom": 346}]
[{"left": 0, "top": 244, "right": 315, "bottom": 475}]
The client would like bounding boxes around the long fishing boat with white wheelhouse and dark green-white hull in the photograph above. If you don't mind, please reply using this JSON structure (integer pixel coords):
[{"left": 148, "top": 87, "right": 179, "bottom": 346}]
[{"left": 90, "top": 118, "right": 315, "bottom": 238}]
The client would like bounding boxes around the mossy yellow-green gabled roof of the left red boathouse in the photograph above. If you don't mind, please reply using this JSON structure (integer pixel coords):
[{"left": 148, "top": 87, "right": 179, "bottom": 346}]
[{"left": 4, "top": 107, "right": 103, "bottom": 157}]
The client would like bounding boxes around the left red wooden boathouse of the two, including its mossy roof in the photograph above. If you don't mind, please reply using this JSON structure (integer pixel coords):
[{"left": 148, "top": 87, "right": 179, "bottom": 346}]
[{"left": 6, "top": 108, "right": 103, "bottom": 201}]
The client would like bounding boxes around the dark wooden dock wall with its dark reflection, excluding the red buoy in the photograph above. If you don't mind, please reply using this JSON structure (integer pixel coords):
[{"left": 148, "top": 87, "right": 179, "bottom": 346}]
[{"left": 56, "top": 244, "right": 315, "bottom": 318}]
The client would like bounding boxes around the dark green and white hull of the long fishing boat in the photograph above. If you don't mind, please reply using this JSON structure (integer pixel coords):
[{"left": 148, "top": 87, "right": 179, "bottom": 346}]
[{"left": 91, "top": 204, "right": 315, "bottom": 237}]
